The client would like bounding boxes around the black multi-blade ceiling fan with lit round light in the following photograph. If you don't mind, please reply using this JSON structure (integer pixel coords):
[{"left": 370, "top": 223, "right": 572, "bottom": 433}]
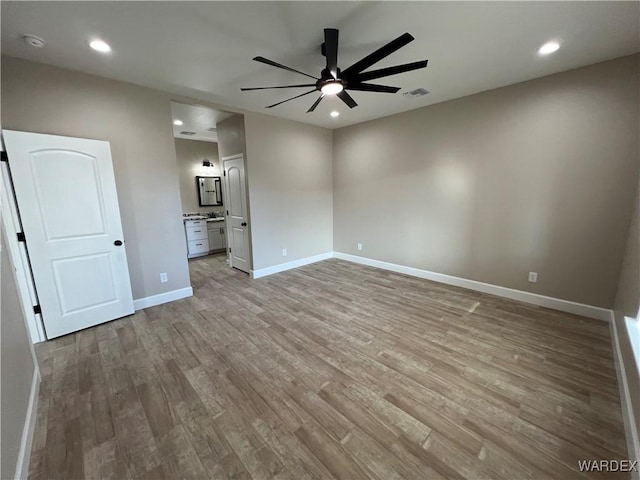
[{"left": 240, "top": 28, "right": 428, "bottom": 113}]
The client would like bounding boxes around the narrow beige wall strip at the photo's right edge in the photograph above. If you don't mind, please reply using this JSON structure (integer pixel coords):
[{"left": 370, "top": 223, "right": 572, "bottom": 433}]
[{"left": 613, "top": 186, "right": 640, "bottom": 442}]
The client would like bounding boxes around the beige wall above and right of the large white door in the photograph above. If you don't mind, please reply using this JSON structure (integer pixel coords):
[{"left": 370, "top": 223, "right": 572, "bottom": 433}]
[{"left": 1, "top": 56, "right": 190, "bottom": 299}]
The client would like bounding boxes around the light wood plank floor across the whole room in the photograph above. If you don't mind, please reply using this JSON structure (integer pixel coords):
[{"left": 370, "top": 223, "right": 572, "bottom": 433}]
[{"left": 30, "top": 257, "right": 628, "bottom": 480}]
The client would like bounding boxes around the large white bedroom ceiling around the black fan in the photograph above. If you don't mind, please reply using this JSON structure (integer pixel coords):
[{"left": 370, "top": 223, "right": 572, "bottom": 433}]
[{"left": 0, "top": 1, "right": 640, "bottom": 128}]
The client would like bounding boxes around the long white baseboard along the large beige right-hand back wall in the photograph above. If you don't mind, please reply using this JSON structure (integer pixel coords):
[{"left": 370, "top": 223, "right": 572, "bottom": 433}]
[{"left": 333, "top": 252, "right": 611, "bottom": 322}]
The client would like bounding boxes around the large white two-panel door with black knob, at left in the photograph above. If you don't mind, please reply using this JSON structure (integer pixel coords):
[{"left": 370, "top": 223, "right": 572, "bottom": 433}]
[{"left": 2, "top": 130, "right": 134, "bottom": 338}]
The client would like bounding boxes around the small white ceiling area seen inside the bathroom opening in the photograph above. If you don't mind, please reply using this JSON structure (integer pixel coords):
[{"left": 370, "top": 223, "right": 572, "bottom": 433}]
[{"left": 171, "top": 102, "right": 233, "bottom": 143}]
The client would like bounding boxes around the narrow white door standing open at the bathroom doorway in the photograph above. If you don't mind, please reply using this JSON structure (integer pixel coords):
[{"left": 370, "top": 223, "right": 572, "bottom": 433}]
[{"left": 222, "top": 155, "right": 251, "bottom": 273}]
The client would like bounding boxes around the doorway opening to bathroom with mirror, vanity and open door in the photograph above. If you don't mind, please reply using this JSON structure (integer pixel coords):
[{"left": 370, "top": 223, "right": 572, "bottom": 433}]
[{"left": 171, "top": 102, "right": 251, "bottom": 273}]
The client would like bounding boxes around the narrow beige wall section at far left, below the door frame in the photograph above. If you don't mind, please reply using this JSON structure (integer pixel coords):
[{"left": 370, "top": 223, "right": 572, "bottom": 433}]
[{"left": 0, "top": 228, "right": 36, "bottom": 478}]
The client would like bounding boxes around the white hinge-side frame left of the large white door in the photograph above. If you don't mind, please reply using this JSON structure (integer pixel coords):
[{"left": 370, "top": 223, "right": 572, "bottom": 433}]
[{"left": 0, "top": 146, "right": 47, "bottom": 344}]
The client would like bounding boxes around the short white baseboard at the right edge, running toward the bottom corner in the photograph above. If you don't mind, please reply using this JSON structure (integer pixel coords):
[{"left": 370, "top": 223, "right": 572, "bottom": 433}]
[{"left": 609, "top": 312, "right": 640, "bottom": 480}]
